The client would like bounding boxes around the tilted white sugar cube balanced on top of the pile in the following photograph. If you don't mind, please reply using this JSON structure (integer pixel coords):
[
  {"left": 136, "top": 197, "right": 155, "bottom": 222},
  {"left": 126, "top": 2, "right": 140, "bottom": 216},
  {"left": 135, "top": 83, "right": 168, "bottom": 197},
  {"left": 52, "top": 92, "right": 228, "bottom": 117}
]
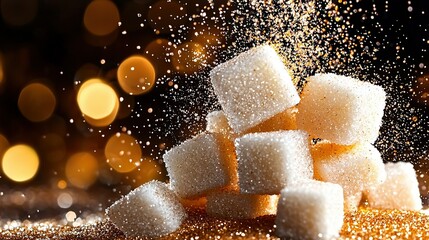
[{"left": 210, "top": 45, "right": 299, "bottom": 133}]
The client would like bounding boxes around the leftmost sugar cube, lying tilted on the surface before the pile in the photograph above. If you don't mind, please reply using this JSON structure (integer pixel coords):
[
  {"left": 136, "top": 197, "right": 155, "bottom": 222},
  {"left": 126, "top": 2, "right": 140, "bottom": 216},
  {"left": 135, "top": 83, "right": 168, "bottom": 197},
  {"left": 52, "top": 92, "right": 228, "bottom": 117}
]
[{"left": 106, "top": 181, "right": 187, "bottom": 237}]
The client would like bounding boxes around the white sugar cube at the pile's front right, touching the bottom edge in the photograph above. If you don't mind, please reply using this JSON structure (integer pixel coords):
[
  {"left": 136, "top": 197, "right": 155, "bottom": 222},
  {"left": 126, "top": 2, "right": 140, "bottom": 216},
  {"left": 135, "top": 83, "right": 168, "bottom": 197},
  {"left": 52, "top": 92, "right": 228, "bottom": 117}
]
[{"left": 275, "top": 180, "right": 344, "bottom": 239}]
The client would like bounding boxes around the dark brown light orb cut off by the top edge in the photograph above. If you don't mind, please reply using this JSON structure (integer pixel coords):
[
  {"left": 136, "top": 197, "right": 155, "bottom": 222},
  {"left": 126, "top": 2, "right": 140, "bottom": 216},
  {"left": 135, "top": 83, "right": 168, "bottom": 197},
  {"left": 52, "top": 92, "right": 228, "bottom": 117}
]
[{"left": 83, "top": 0, "right": 120, "bottom": 36}]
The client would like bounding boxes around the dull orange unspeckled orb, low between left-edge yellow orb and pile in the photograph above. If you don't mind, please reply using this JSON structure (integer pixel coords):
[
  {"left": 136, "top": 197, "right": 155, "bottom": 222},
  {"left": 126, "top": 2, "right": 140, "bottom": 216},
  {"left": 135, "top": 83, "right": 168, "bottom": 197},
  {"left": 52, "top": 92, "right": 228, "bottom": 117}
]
[{"left": 66, "top": 152, "right": 98, "bottom": 189}]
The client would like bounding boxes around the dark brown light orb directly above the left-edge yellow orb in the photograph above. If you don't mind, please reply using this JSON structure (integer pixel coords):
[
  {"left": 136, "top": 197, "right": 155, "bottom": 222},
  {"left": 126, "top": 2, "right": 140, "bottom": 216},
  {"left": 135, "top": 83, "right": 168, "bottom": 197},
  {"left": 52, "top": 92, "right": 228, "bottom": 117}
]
[{"left": 18, "top": 83, "right": 57, "bottom": 122}]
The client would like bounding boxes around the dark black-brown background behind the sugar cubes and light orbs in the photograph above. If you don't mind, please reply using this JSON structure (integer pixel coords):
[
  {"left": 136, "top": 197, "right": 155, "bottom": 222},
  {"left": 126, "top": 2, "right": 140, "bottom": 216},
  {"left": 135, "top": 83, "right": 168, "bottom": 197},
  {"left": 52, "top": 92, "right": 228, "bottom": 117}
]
[{"left": 0, "top": 0, "right": 429, "bottom": 216}]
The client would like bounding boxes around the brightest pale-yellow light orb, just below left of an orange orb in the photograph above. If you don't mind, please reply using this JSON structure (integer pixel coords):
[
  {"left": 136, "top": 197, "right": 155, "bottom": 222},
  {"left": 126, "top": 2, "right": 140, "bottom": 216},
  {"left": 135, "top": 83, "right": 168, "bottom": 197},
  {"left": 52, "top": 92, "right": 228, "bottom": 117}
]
[{"left": 77, "top": 78, "right": 119, "bottom": 123}]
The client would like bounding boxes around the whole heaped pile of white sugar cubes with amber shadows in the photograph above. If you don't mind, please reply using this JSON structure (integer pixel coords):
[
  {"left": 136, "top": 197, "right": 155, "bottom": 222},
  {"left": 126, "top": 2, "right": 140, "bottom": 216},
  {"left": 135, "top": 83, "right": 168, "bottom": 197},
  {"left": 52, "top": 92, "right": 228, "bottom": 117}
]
[{"left": 106, "top": 45, "right": 422, "bottom": 239}]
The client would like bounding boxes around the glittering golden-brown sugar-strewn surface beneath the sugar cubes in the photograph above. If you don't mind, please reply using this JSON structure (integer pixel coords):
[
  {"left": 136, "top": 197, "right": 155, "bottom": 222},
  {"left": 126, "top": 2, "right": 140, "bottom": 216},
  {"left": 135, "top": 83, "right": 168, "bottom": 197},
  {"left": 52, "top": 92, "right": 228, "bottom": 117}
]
[{"left": 0, "top": 208, "right": 429, "bottom": 239}]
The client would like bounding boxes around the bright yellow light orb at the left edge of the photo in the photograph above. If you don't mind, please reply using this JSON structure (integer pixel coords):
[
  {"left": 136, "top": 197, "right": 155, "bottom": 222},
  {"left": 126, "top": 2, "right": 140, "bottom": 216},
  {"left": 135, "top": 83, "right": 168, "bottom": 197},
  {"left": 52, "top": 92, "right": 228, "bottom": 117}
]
[{"left": 2, "top": 144, "right": 39, "bottom": 182}]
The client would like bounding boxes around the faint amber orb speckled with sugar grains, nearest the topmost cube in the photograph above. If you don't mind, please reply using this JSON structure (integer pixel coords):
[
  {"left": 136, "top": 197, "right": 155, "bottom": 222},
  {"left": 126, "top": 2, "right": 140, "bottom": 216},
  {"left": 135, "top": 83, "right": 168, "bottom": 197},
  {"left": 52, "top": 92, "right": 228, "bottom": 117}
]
[{"left": 172, "top": 42, "right": 207, "bottom": 74}]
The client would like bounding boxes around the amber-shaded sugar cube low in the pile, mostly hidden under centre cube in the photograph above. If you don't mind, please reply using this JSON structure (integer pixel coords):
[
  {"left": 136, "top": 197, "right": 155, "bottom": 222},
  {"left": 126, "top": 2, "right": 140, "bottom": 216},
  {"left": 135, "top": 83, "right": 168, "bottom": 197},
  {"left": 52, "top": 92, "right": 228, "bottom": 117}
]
[{"left": 206, "top": 191, "right": 278, "bottom": 219}]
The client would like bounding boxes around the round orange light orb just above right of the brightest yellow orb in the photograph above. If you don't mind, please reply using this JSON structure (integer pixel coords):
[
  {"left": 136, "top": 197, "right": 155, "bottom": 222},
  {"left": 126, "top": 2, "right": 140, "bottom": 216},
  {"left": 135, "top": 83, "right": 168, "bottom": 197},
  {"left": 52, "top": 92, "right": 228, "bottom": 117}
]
[{"left": 117, "top": 56, "right": 155, "bottom": 95}]
